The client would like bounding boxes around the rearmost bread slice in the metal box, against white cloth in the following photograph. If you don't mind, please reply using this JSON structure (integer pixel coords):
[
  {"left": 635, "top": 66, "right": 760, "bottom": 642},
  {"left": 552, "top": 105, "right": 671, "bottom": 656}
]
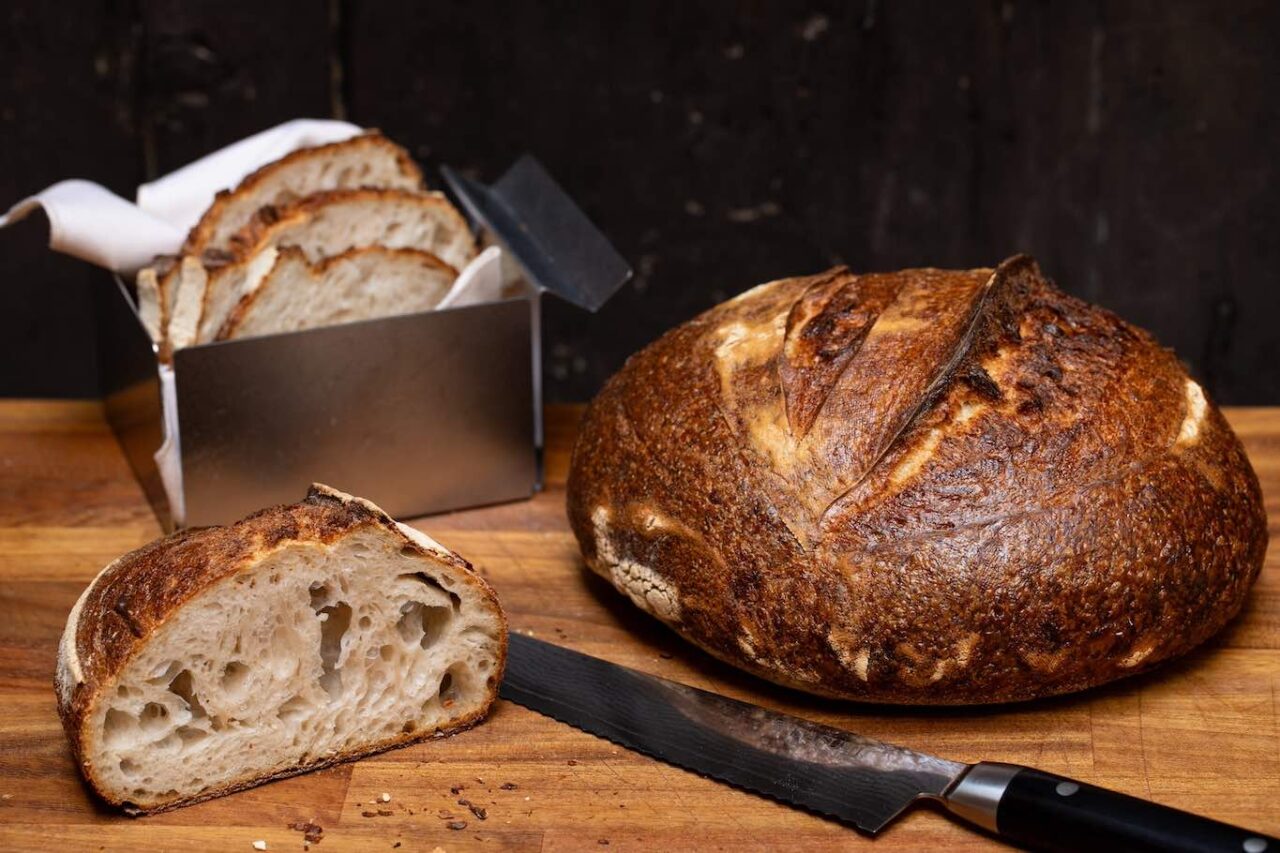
[{"left": 183, "top": 131, "right": 422, "bottom": 255}]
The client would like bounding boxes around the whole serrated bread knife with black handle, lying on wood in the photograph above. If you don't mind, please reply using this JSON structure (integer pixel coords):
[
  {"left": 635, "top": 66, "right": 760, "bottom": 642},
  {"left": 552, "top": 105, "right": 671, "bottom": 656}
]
[{"left": 500, "top": 631, "right": 1280, "bottom": 853}]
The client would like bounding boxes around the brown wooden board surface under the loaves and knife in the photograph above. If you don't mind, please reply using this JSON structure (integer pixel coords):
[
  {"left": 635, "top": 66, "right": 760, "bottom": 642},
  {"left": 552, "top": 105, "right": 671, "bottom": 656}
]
[{"left": 0, "top": 402, "right": 1280, "bottom": 853}]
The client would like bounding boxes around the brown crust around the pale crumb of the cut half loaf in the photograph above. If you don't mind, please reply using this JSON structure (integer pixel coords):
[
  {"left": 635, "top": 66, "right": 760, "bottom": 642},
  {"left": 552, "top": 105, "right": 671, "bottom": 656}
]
[{"left": 54, "top": 484, "right": 507, "bottom": 813}]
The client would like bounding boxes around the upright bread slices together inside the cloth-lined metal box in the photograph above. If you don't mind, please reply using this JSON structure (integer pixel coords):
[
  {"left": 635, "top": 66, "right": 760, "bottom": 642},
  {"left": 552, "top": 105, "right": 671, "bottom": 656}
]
[{"left": 137, "top": 132, "right": 475, "bottom": 348}]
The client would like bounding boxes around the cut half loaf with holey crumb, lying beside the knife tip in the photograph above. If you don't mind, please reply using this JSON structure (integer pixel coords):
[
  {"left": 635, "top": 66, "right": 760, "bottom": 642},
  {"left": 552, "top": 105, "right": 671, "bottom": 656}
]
[{"left": 55, "top": 485, "right": 507, "bottom": 813}]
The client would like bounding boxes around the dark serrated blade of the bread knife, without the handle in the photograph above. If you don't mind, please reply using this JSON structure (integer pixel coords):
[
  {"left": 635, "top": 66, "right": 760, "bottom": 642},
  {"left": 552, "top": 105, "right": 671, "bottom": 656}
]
[{"left": 502, "top": 633, "right": 966, "bottom": 833}]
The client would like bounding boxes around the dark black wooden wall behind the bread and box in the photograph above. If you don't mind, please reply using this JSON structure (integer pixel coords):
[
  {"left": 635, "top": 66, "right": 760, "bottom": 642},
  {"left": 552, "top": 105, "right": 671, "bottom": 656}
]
[{"left": 0, "top": 0, "right": 1280, "bottom": 403}]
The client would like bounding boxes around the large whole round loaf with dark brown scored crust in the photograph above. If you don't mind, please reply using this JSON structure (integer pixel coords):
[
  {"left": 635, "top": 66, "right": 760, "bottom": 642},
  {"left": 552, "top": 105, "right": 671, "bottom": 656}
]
[{"left": 568, "top": 257, "right": 1267, "bottom": 704}]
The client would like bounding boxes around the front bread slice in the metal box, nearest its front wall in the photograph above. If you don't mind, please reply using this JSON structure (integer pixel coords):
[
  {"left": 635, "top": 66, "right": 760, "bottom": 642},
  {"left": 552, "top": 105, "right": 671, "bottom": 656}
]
[{"left": 218, "top": 246, "right": 457, "bottom": 341}]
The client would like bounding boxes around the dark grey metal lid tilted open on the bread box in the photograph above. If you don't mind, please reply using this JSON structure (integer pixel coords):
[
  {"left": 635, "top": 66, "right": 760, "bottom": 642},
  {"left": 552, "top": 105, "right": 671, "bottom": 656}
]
[{"left": 440, "top": 154, "right": 631, "bottom": 311}]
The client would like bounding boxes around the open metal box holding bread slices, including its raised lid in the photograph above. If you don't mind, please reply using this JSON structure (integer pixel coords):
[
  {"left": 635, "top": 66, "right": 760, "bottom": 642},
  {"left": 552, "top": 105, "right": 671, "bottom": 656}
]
[{"left": 96, "top": 156, "right": 631, "bottom": 530}]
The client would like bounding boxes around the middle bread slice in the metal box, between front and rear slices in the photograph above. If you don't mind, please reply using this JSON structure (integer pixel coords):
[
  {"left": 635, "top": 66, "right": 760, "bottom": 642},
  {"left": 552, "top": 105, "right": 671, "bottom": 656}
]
[{"left": 183, "top": 190, "right": 475, "bottom": 346}]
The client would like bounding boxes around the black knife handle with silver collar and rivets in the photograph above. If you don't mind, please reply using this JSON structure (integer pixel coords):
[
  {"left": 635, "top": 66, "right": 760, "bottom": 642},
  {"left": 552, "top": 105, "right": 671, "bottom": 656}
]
[{"left": 947, "top": 762, "right": 1280, "bottom": 853}]
